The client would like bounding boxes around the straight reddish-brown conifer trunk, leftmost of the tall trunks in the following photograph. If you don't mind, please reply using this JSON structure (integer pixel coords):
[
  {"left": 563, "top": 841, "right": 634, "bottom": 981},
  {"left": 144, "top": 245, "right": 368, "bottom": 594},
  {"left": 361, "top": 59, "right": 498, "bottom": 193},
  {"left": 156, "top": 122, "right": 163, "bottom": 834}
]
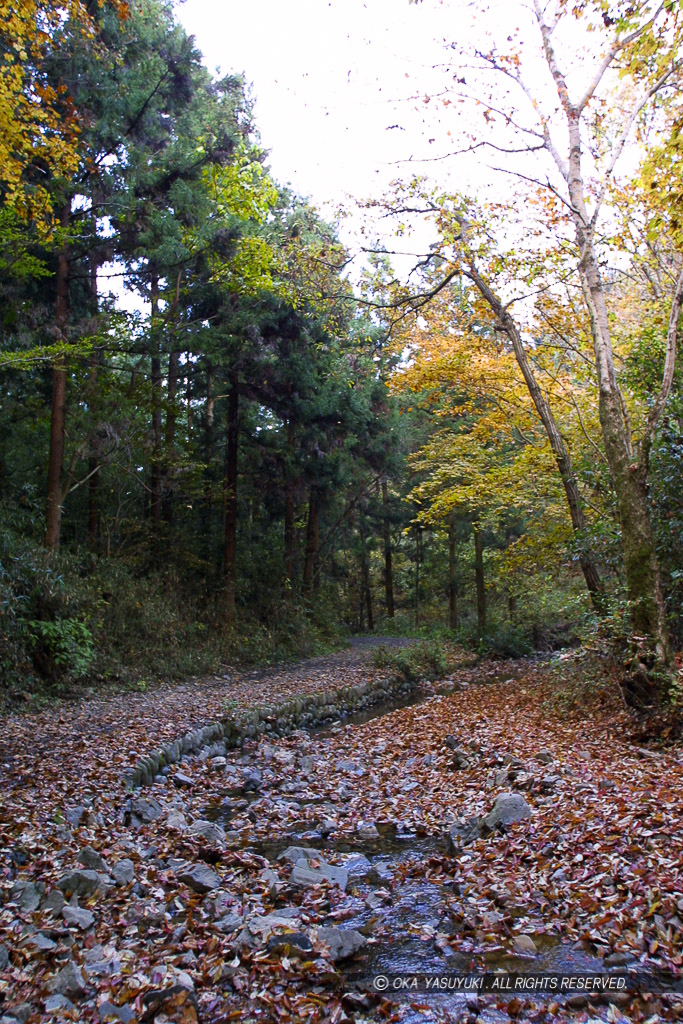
[{"left": 45, "top": 200, "right": 71, "bottom": 552}]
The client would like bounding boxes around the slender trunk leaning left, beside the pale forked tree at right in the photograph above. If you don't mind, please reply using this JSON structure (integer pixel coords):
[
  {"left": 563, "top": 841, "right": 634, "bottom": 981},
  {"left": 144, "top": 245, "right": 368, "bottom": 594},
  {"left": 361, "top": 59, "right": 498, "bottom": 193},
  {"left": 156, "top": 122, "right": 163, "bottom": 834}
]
[{"left": 468, "top": 263, "right": 607, "bottom": 614}]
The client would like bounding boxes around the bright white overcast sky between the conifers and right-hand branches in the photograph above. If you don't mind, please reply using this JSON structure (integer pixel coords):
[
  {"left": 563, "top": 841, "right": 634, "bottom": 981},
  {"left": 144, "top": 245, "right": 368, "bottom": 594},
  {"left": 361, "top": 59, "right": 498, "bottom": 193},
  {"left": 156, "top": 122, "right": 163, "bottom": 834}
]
[{"left": 109, "top": 0, "right": 643, "bottom": 307}]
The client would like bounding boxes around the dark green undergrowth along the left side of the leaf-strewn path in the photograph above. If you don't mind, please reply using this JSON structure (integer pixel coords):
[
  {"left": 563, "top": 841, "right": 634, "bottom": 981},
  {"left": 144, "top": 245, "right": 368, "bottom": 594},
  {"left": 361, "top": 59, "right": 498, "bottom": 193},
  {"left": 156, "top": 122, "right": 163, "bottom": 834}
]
[{"left": 0, "top": 523, "right": 343, "bottom": 707}]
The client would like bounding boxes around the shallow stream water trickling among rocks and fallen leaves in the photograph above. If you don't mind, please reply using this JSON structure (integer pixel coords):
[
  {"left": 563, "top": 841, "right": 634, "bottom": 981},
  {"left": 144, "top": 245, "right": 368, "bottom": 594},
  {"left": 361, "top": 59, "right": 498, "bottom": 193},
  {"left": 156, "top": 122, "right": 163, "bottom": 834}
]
[{"left": 205, "top": 659, "right": 626, "bottom": 1021}]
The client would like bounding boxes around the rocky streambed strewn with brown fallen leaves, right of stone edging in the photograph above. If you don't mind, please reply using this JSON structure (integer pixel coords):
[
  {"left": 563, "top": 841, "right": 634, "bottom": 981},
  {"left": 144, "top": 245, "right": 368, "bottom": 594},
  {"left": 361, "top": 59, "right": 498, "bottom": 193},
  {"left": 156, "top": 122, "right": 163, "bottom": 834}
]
[{"left": 0, "top": 651, "right": 683, "bottom": 1024}]
